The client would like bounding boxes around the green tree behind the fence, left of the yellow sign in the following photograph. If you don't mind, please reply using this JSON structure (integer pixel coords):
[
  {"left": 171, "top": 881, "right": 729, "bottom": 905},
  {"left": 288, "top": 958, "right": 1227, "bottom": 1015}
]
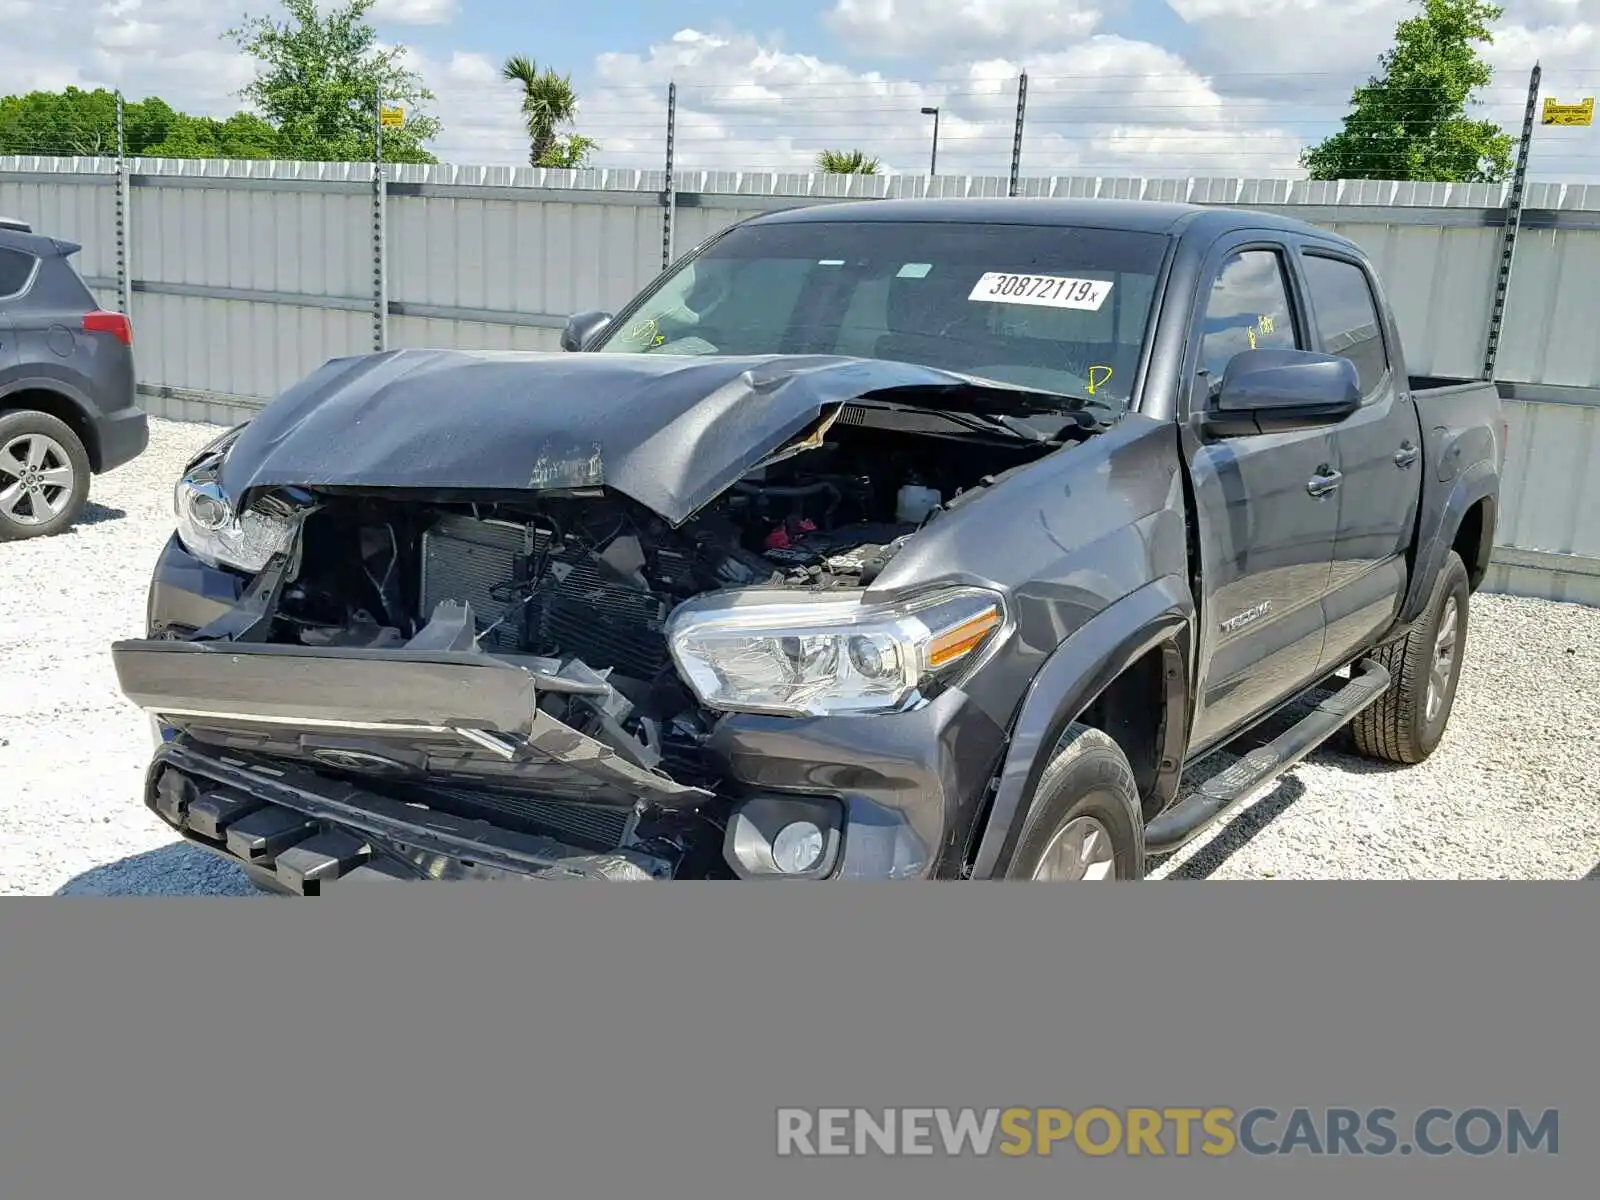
[{"left": 1301, "top": 0, "right": 1512, "bottom": 182}]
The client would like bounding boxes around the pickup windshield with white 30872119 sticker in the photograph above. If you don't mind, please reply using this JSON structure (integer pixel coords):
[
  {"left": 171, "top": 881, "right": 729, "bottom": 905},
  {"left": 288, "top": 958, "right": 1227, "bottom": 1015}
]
[{"left": 595, "top": 221, "right": 1168, "bottom": 408}]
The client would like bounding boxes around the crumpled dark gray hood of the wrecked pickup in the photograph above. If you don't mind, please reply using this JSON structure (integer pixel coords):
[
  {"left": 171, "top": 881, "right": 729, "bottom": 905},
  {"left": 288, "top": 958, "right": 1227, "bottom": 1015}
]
[{"left": 219, "top": 350, "right": 998, "bottom": 523}]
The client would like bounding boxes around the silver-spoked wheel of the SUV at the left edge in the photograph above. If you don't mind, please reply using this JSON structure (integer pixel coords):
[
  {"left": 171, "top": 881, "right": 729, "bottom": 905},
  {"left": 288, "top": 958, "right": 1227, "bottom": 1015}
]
[{"left": 0, "top": 413, "right": 90, "bottom": 541}]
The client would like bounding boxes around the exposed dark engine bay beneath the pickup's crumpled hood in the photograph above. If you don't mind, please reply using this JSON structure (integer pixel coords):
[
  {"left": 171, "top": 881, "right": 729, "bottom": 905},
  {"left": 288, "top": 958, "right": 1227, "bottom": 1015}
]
[{"left": 274, "top": 427, "right": 1037, "bottom": 662}]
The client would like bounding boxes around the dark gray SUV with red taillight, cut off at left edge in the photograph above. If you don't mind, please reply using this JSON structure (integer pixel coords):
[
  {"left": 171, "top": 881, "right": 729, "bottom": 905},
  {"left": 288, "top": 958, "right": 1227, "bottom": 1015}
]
[{"left": 0, "top": 218, "right": 150, "bottom": 541}]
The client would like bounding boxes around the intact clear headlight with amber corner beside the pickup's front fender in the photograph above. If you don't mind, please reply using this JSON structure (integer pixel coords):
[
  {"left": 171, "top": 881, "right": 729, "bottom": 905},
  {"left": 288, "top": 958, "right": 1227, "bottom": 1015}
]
[{"left": 667, "top": 587, "right": 1005, "bottom": 715}]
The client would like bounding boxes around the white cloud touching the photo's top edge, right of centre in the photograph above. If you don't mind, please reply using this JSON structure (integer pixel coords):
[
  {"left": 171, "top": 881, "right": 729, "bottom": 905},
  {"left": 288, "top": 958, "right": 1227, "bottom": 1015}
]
[{"left": 827, "top": 0, "right": 1101, "bottom": 54}]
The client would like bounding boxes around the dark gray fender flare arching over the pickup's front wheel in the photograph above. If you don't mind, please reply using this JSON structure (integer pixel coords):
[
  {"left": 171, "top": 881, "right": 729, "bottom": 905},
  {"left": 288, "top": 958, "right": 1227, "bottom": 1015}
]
[{"left": 953, "top": 576, "right": 1195, "bottom": 878}]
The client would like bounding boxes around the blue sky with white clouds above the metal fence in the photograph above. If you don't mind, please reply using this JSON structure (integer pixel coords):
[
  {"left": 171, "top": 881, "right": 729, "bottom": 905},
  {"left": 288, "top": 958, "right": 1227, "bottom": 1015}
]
[{"left": 0, "top": 0, "right": 1600, "bottom": 181}]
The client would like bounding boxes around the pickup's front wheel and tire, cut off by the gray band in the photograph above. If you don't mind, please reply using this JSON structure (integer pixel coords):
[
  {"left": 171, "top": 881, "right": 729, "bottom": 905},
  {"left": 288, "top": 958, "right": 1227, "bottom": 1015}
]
[{"left": 1006, "top": 725, "right": 1144, "bottom": 882}]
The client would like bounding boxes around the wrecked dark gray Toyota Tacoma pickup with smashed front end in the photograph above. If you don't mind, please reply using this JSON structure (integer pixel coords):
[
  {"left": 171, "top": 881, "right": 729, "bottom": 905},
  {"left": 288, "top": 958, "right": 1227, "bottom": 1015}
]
[{"left": 114, "top": 200, "right": 1506, "bottom": 894}]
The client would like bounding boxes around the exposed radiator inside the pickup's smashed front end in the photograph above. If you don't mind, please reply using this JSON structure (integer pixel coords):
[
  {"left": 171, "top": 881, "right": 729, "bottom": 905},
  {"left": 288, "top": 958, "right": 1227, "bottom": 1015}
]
[{"left": 421, "top": 517, "right": 669, "bottom": 680}]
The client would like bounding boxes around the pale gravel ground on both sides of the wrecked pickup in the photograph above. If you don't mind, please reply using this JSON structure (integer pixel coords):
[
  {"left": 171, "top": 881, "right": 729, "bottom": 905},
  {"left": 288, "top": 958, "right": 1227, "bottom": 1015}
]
[{"left": 0, "top": 421, "right": 1600, "bottom": 894}]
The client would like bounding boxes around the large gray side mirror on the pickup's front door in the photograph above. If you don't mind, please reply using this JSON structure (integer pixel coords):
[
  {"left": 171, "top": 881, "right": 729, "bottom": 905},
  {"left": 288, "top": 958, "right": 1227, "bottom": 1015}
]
[{"left": 1205, "top": 350, "right": 1362, "bottom": 437}]
